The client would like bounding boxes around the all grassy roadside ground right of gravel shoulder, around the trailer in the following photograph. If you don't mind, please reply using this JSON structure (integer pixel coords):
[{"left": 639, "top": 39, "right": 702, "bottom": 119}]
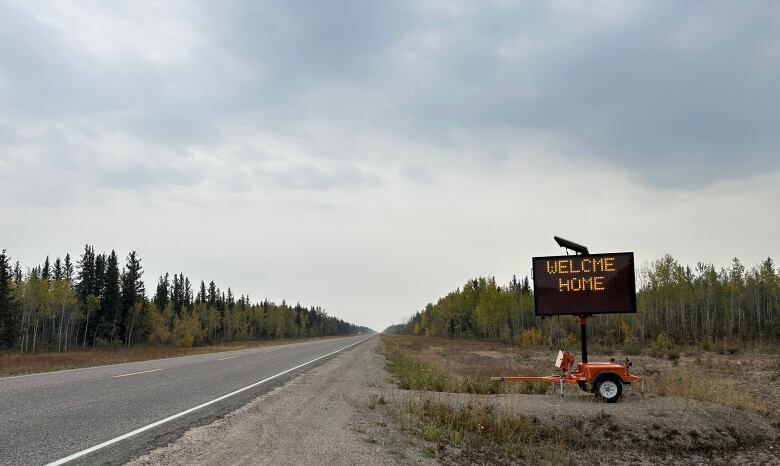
[{"left": 380, "top": 335, "right": 780, "bottom": 464}]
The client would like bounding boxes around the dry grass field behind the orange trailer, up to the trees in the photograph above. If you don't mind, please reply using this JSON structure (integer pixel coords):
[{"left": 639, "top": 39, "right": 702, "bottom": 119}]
[{"left": 382, "top": 335, "right": 780, "bottom": 419}]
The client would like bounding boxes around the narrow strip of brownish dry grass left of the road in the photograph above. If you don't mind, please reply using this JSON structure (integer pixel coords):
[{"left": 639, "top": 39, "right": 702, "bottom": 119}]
[{"left": 0, "top": 337, "right": 338, "bottom": 377}]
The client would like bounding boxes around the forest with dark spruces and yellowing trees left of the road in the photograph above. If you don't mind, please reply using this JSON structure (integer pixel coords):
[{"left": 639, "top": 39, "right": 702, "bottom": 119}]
[{"left": 0, "top": 245, "right": 370, "bottom": 352}]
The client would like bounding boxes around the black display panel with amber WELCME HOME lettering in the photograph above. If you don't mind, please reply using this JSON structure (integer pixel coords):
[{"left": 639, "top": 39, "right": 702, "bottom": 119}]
[{"left": 533, "top": 252, "right": 636, "bottom": 316}]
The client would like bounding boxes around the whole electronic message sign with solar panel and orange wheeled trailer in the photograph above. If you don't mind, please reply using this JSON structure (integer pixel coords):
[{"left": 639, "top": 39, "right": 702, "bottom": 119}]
[{"left": 493, "top": 236, "right": 640, "bottom": 403}]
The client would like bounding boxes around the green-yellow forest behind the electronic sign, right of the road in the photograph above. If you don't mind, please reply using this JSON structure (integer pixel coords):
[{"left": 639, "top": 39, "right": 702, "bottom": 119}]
[{"left": 394, "top": 255, "right": 780, "bottom": 348}]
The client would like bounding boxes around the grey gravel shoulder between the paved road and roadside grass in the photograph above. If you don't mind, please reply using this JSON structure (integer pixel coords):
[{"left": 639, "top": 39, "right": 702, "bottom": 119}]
[{"left": 128, "top": 338, "right": 436, "bottom": 465}]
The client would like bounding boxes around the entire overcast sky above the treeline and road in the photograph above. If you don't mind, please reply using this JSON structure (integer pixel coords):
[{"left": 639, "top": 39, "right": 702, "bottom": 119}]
[{"left": 0, "top": 0, "right": 780, "bottom": 330}]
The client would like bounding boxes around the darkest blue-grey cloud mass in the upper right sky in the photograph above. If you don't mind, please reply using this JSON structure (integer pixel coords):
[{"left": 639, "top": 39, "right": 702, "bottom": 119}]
[{"left": 374, "top": 2, "right": 780, "bottom": 187}]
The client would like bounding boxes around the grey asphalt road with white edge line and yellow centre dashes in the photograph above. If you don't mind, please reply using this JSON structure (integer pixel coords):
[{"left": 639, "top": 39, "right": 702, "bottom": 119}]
[{"left": 0, "top": 335, "right": 374, "bottom": 465}]
